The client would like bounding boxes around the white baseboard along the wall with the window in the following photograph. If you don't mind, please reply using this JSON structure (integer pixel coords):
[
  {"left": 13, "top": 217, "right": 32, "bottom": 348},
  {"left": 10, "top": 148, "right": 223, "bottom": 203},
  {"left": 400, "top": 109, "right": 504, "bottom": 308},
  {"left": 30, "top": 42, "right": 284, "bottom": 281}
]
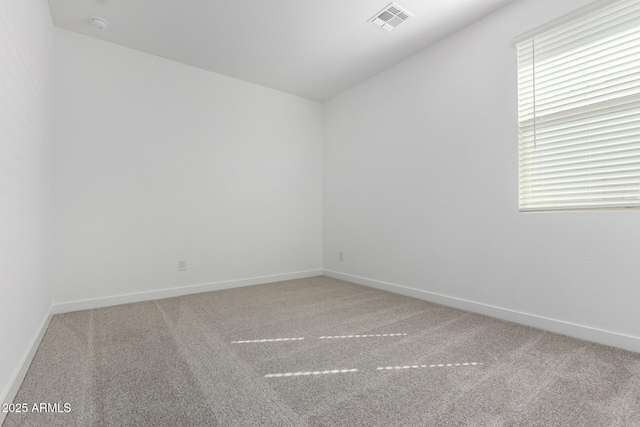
[{"left": 324, "top": 270, "right": 640, "bottom": 353}]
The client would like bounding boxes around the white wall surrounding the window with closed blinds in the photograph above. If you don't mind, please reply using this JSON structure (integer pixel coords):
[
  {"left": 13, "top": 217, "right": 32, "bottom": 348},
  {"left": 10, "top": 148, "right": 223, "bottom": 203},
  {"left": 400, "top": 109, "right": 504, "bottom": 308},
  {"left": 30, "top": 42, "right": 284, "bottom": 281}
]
[{"left": 323, "top": 0, "right": 640, "bottom": 351}]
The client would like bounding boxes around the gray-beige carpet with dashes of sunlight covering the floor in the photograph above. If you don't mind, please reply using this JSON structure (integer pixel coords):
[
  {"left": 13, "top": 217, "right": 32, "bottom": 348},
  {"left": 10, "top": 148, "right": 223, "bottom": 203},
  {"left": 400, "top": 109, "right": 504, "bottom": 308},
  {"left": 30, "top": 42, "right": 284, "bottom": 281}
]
[{"left": 4, "top": 277, "right": 640, "bottom": 427}]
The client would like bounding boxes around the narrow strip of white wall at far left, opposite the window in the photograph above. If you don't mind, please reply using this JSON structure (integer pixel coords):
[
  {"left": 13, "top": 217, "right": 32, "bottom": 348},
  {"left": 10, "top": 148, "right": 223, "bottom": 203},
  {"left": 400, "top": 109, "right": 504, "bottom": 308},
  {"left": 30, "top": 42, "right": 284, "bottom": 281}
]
[{"left": 0, "top": 0, "right": 53, "bottom": 410}]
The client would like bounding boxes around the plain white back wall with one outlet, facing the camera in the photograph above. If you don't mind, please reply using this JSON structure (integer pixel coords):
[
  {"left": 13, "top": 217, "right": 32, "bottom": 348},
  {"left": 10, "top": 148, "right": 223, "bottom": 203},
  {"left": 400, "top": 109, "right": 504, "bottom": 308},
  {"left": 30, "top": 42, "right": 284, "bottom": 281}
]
[{"left": 54, "top": 29, "right": 322, "bottom": 303}]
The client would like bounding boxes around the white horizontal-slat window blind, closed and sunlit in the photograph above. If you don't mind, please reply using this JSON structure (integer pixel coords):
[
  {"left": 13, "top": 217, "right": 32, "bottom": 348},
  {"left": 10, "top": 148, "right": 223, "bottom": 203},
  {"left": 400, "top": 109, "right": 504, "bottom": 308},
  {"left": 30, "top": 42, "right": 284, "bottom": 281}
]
[{"left": 516, "top": 0, "right": 640, "bottom": 211}]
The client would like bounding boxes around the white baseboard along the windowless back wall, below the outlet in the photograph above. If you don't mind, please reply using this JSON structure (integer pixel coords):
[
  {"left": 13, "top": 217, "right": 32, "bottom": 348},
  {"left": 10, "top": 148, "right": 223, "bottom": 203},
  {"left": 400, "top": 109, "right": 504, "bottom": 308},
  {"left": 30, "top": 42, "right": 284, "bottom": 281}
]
[{"left": 52, "top": 270, "right": 323, "bottom": 314}]
